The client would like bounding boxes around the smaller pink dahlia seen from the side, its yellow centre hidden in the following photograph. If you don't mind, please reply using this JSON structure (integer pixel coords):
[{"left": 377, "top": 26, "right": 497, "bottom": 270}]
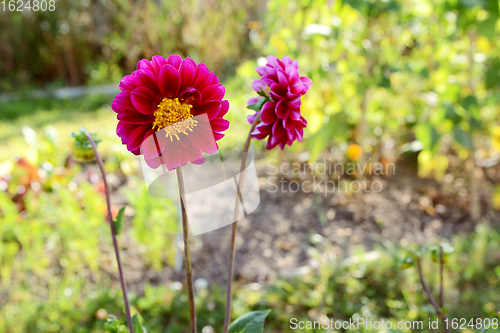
[{"left": 248, "top": 56, "right": 312, "bottom": 149}]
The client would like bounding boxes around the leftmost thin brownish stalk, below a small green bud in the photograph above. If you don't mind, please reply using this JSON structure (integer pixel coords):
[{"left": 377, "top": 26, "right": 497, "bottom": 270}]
[{"left": 86, "top": 134, "right": 134, "bottom": 333}]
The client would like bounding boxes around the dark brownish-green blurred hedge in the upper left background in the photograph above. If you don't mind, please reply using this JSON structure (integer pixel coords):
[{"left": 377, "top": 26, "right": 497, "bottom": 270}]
[{"left": 0, "top": 0, "right": 265, "bottom": 91}]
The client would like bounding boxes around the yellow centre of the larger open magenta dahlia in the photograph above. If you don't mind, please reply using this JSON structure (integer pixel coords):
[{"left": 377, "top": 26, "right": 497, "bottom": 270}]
[{"left": 153, "top": 97, "right": 197, "bottom": 141}]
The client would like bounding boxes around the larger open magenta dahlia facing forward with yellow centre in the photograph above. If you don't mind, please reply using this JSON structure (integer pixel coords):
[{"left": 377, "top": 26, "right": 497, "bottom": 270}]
[{"left": 112, "top": 55, "right": 229, "bottom": 170}]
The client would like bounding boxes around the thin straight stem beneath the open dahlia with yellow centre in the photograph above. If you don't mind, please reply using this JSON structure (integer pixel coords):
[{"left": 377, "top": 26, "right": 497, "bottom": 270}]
[{"left": 175, "top": 166, "right": 196, "bottom": 333}]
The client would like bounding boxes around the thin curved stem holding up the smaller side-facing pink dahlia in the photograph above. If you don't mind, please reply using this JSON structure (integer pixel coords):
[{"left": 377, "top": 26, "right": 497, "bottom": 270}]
[{"left": 222, "top": 114, "right": 260, "bottom": 333}]
